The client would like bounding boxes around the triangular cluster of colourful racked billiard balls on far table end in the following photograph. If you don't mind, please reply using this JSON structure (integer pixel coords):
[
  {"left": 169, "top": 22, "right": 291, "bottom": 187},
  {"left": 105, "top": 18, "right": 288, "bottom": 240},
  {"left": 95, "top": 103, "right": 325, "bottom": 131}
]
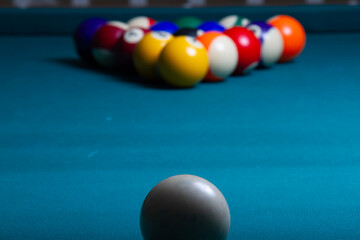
[{"left": 74, "top": 15, "right": 306, "bottom": 88}]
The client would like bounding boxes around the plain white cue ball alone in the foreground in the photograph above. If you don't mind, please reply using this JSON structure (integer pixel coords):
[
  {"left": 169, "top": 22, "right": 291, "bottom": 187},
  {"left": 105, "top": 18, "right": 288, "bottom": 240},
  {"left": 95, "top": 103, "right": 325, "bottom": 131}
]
[{"left": 140, "top": 175, "right": 230, "bottom": 240}]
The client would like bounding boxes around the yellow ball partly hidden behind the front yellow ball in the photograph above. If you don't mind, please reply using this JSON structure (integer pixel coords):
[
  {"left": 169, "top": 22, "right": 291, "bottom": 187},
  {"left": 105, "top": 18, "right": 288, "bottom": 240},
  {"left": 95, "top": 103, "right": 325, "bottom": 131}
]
[{"left": 133, "top": 31, "right": 174, "bottom": 80}]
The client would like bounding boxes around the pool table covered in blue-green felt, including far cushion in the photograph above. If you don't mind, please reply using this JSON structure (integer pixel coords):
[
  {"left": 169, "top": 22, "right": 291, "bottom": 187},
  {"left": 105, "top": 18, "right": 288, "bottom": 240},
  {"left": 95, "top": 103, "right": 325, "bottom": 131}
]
[{"left": 0, "top": 6, "right": 360, "bottom": 240}]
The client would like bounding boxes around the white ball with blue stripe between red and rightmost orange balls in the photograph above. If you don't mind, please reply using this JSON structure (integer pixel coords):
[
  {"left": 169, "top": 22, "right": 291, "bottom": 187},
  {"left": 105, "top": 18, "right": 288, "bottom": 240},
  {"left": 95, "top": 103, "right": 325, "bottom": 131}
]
[{"left": 247, "top": 21, "right": 284, "bottom": 67}]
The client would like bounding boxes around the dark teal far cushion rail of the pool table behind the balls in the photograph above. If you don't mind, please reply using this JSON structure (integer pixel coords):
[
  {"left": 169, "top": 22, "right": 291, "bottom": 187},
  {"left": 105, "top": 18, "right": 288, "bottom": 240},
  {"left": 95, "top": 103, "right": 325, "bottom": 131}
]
[{"left": 0, "top": 5, "right": 360, "bottom": 35}]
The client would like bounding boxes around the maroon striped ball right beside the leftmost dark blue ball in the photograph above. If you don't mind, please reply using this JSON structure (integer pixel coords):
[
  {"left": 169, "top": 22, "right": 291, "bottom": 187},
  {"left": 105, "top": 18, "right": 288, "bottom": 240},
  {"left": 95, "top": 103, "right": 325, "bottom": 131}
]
[{"left": 92, "top": 21, "right": 128, "bottom": 68}]
